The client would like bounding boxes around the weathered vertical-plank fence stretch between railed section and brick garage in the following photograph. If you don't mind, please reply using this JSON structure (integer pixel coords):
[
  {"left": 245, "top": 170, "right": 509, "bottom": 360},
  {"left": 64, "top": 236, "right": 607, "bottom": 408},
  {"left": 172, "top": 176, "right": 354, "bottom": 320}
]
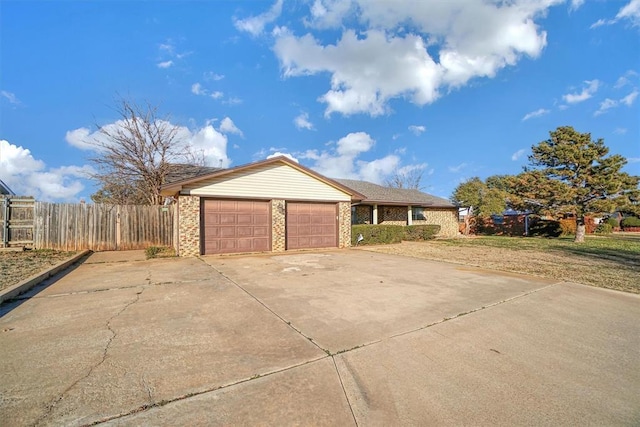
[{"left": 34, "top": 202, "right": 175, "bottom": 251}]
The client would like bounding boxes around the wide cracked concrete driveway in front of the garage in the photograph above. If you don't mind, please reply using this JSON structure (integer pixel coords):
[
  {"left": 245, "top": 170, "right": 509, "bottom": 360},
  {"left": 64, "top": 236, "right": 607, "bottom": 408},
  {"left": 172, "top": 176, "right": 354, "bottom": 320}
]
[{"left": 0, "top": 249, "right": 640, "bottom": 426}]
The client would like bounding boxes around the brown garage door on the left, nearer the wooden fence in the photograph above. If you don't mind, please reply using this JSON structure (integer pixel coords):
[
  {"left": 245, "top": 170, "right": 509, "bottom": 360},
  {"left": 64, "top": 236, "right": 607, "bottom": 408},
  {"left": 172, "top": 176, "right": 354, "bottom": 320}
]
[{"left": 202, "top": 199, "right": 271, "bottom": 255}]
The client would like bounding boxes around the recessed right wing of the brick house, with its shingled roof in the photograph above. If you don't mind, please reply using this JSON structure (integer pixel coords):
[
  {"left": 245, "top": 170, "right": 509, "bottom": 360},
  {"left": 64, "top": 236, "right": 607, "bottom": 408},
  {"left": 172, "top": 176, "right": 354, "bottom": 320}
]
[{"left": 336, "top": 179, "right": 458, "bottom": 237}]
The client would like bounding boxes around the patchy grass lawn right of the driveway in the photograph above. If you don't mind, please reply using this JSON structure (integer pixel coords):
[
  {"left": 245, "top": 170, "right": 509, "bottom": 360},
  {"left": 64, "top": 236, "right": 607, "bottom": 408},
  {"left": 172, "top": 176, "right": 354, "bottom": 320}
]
[{"left": 362, "top": 234, "right": 640, "bottom": 293}]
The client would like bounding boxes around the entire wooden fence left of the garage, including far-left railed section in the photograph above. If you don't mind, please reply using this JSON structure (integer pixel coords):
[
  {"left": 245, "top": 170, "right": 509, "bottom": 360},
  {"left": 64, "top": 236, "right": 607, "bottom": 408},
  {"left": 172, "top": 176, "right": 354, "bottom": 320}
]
[{"left": 0, "top": 196, "right": 175, "bottom": 251}]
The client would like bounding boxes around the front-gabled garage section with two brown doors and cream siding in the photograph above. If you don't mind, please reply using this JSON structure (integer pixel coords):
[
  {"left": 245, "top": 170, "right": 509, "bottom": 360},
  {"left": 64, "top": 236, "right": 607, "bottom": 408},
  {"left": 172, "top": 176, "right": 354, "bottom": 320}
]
[{"left": 161, "top": 156, "right": 363, "bottom": 256}]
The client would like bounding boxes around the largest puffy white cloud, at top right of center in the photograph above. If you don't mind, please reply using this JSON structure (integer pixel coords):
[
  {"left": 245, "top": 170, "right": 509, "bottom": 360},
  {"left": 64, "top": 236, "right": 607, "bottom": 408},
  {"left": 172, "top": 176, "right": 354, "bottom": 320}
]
[{"left": 273, "top": 0, "right": 560, "bottom": 116}]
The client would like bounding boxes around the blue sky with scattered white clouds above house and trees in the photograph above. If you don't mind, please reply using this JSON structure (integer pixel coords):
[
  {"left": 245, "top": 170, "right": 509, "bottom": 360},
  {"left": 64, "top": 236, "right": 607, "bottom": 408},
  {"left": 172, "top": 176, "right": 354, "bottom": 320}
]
[{"left": 0, "top": 0, "right": 640, "bottom": 201}]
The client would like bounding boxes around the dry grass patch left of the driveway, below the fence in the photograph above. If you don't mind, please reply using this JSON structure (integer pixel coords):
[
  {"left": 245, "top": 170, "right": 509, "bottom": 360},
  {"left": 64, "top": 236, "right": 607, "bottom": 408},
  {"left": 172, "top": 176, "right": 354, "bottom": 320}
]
[{"left": 0, "top": 250, "right": 75, "bottom": 291}]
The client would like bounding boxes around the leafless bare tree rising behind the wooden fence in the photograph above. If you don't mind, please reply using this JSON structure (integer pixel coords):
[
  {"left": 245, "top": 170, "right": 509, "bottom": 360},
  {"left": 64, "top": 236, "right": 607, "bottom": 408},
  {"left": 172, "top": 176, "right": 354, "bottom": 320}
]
[{"left": 89, "top": 98, "right": 203, "bottom": 205}]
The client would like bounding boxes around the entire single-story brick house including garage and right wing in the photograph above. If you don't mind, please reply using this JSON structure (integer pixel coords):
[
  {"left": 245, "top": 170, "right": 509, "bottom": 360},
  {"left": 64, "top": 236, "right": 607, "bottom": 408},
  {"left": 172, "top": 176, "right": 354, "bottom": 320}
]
[{"left": 161, "top": 156, "right": 458, "bottom": 256}]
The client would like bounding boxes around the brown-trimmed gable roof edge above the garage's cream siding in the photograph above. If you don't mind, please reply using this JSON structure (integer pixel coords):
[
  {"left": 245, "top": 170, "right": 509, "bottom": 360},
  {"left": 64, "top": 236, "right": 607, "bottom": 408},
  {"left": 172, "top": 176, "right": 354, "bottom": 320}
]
[{"left": 160, "top": 156, "right": 364, "bottom": 200}]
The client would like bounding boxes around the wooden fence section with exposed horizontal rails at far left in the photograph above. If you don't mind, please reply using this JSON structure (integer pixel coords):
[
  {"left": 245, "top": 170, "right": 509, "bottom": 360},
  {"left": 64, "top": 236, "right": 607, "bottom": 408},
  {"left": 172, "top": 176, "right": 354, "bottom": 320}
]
[{"left": 0, "top": 196, "right": 35, "bottom": 248}]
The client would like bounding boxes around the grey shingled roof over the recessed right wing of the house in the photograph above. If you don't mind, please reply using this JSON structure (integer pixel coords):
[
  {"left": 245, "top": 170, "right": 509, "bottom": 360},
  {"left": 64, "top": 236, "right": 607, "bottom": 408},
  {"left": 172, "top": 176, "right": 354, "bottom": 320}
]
[{"left": 336, "top": 179, "right": 456, "bottom": 208}]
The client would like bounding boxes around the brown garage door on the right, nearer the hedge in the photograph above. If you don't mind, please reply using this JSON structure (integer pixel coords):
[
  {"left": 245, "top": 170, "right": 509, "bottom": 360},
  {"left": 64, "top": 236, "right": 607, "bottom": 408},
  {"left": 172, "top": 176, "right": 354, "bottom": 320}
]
[{"left": 287, "top": 203, "right": 338, "bottom": 249}]
